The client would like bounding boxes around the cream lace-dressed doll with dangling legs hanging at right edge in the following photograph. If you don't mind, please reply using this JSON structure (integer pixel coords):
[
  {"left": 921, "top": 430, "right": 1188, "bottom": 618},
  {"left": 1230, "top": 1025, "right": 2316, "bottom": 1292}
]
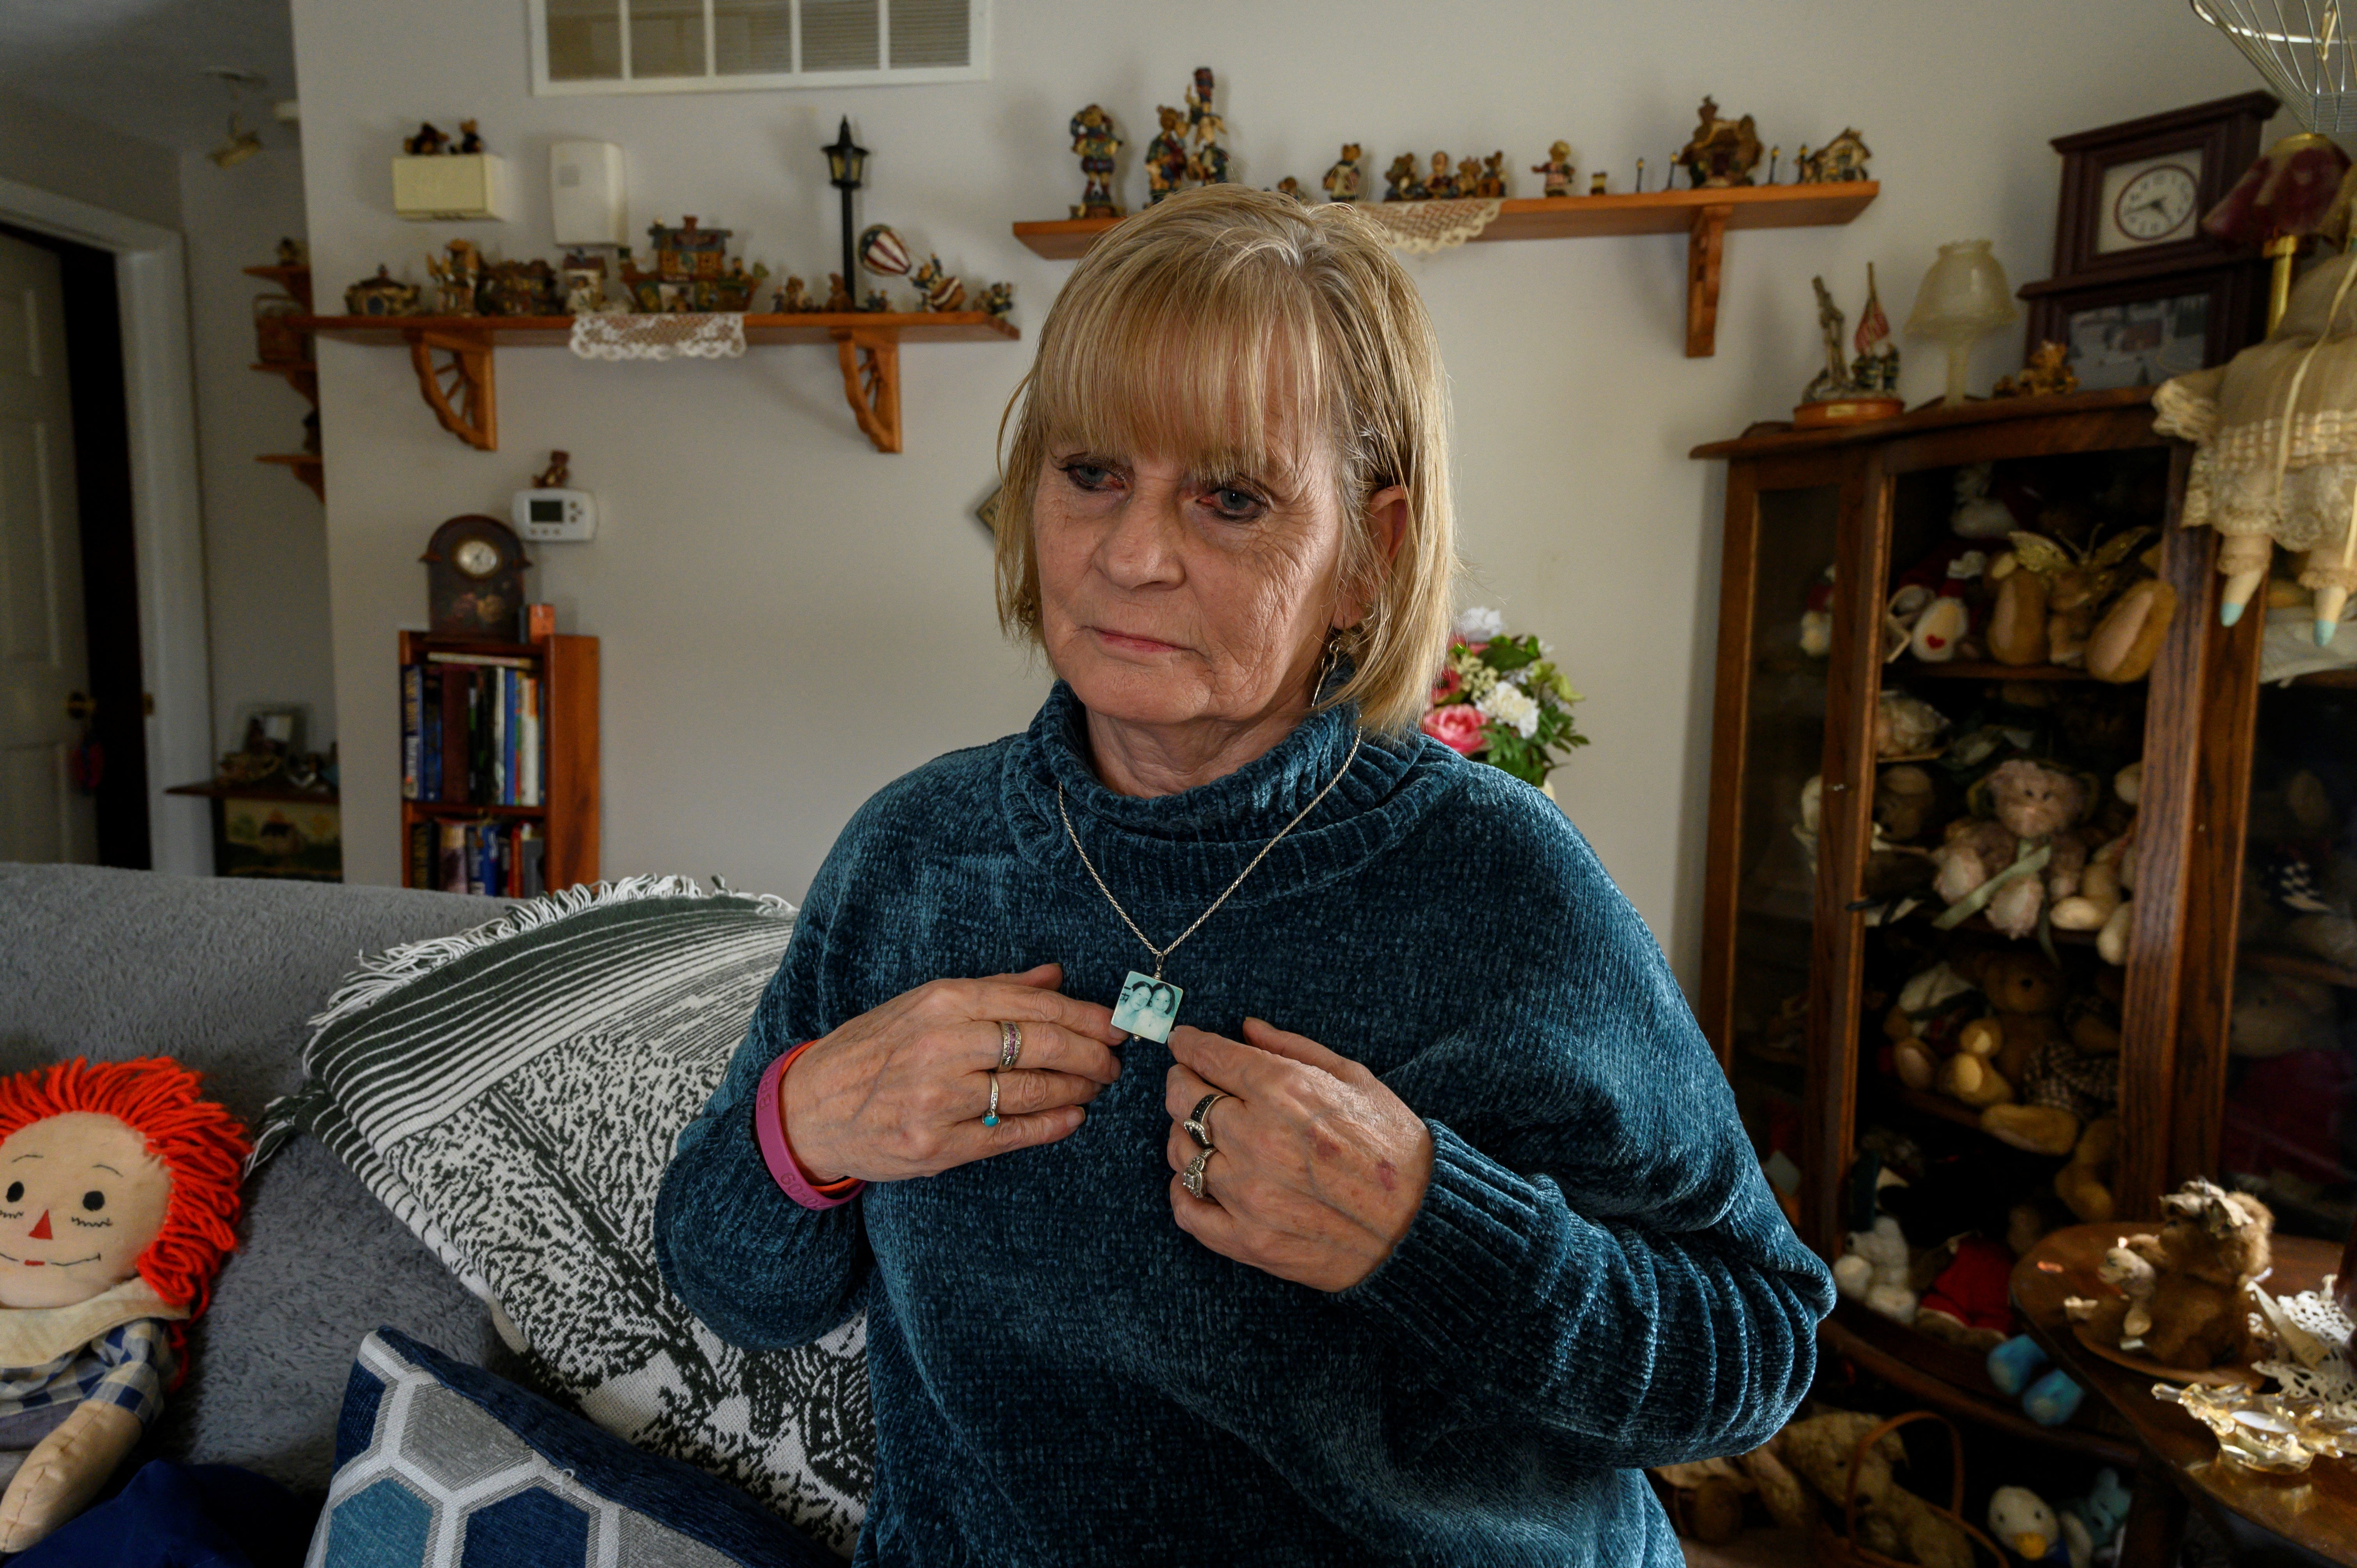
[{"left": 2152, "top": 220, "right": 2357, "bottom": 646}]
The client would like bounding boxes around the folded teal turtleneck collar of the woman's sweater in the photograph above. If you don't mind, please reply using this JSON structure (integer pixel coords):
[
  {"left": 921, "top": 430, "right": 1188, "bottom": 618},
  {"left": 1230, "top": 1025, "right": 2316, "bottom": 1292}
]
[{"left": 1004, "top": 682, "right": 1464, "bottom": 919}]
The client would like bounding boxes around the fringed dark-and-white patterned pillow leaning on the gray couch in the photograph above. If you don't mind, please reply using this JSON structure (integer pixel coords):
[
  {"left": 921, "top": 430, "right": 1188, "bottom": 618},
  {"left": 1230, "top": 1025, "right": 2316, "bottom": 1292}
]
[{"left": 257, "top": 877, "right": 875, "bottom": 1554}]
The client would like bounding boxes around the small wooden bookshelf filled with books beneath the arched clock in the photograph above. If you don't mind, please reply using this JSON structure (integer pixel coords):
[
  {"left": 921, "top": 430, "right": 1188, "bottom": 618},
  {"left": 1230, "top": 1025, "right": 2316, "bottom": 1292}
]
[{"left": 398, "top": 632, "right": 601, "bottom": 896}]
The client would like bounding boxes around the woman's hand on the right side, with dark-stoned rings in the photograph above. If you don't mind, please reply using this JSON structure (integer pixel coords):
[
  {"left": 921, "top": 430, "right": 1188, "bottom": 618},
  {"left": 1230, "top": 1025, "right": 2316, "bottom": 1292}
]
[{"left": 1162, "top": 1019, "right": 1433, "bottom": 1290}]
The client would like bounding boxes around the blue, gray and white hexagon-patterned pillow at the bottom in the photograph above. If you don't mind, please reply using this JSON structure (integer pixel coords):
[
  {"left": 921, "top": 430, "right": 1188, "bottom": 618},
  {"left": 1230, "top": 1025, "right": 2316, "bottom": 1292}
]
[{"left": 309, "top": 1328, "right": 841, "bottom": 1568}]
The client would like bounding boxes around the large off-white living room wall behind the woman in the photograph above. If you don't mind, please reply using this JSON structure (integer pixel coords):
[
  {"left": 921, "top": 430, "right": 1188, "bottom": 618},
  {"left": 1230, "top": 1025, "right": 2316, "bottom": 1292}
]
[{"left": 295, "top": 0, "right": 2258, "bottom": 971}]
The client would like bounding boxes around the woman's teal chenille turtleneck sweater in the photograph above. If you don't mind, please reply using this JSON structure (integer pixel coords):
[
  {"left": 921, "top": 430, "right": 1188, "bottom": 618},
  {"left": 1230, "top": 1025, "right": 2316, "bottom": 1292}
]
[{"left": 655, "top": 686, "right": 1834, "bottom": 1568}]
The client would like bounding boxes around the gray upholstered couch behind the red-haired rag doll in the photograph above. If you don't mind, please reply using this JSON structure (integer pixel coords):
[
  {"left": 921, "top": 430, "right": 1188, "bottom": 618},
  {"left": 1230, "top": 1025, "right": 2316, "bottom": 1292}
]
[{"left": 0, "top": 863, "right": 518, "bottom": 1492}]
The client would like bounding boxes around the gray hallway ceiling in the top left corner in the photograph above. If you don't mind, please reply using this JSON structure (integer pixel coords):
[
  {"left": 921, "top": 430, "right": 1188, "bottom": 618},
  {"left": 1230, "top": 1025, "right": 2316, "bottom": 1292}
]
[{"left": 0, "top": 0, "right": 295, "bottom": 151}]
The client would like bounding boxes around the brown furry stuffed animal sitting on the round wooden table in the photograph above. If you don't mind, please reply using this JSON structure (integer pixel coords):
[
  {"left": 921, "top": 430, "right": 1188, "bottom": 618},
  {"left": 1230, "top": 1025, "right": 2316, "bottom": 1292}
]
[{"left": 2062, "top": 1177, "right": 2274, "bottom": 1370}]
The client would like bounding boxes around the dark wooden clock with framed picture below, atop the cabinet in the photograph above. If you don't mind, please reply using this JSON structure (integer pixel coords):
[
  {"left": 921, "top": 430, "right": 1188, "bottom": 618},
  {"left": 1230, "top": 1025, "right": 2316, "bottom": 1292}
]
[{"left": 2020, "top": 92, "right": 2279, "bottom": 389}]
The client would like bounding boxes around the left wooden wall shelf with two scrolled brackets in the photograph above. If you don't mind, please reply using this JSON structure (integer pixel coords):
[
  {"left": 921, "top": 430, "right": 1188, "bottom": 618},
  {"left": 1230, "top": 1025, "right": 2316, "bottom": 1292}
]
[{"left": 304, "top": 311, "right": 1023, "bottom": 453}]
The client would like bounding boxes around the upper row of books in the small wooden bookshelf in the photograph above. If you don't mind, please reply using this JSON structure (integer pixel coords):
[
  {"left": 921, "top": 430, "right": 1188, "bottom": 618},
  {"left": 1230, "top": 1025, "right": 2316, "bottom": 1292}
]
[{"left": 401, "top": 653, "right": 547, "bottom": 806}]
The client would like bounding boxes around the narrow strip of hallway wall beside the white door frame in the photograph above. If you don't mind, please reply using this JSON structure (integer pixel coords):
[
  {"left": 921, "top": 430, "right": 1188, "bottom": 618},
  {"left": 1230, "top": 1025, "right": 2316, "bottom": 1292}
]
[{"left": 167, "top": 146, "right": 337, "bottom": 759}]
